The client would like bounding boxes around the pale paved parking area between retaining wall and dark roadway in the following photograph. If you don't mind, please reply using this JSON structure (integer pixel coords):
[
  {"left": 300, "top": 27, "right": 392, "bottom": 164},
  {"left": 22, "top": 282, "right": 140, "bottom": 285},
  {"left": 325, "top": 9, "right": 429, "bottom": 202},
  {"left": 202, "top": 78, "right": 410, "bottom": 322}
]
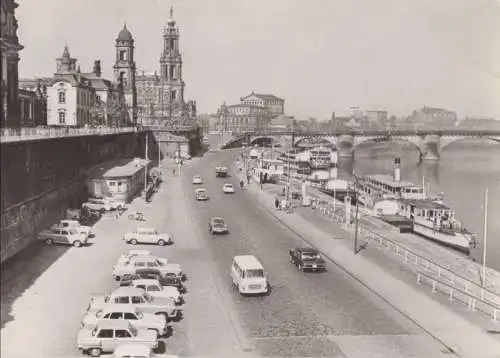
[{"left": 0, "top": 160, "right": 254, "bottom": 358}]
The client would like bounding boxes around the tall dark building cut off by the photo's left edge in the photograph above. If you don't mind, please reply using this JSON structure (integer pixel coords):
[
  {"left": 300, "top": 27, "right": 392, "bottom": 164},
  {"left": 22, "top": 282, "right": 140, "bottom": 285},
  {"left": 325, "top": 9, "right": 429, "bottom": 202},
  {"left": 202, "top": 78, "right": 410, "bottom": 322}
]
[{"left": 0, "top": 0, "right": 24, "bottom": 127}]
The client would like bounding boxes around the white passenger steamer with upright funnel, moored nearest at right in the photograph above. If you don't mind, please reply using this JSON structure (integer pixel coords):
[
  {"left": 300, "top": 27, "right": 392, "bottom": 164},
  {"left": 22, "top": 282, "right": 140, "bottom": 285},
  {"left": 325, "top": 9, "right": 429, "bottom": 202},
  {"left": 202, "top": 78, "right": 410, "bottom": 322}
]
[{"left": 356, "top": 158, "right": 476, "bottom": 253}]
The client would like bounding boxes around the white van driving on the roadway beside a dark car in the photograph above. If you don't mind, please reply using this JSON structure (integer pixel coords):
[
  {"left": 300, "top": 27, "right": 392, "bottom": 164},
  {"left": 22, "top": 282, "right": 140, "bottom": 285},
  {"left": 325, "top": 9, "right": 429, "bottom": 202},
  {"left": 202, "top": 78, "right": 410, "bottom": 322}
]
[{"left": 231, "top": 255, "right": 269, "bottom": 294}]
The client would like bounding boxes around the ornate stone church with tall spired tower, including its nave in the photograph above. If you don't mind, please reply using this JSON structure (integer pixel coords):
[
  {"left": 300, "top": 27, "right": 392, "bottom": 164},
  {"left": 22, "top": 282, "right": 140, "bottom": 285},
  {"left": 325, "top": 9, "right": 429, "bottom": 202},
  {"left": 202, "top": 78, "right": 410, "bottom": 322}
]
[{"left": 136, "top": 8, "right": 196, "bottom": 126}]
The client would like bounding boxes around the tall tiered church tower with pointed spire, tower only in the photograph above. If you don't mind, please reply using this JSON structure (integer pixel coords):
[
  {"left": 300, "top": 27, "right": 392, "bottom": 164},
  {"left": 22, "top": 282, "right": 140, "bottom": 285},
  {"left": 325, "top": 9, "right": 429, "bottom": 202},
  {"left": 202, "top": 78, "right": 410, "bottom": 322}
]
[{"left": 160, "top": 7, "right": 184, "bottom": 116}]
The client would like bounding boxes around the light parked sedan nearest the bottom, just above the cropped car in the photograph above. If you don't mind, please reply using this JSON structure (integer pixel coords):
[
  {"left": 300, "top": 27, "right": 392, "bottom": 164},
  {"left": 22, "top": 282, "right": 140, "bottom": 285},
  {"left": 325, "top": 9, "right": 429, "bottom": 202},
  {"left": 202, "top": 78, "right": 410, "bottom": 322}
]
[{"left": 77, "top": 320, "right": 158, "bottom": 357}]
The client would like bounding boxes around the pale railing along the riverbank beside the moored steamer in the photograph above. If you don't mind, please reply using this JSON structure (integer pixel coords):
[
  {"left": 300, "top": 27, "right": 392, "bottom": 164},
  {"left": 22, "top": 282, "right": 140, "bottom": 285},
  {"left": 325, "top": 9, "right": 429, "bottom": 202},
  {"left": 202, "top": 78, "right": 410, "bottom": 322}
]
[{"left": 317, "top": 203, "right": 500, "bottom": 320}]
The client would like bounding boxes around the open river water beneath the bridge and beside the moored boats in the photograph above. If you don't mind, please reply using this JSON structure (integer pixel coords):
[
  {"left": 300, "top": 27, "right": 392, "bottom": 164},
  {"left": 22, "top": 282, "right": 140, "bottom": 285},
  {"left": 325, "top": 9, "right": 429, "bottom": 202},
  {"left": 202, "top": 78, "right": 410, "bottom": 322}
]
[{"left": 339, "top": 142, "right": 500, "bottom": 271}]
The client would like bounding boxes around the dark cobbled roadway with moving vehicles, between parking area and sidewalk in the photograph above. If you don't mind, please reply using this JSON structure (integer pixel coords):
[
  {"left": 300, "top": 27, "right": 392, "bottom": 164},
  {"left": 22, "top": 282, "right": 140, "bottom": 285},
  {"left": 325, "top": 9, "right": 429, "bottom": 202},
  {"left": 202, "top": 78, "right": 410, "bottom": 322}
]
[{"left": 183, "top": 151, "right": 450, "bottom": 357}]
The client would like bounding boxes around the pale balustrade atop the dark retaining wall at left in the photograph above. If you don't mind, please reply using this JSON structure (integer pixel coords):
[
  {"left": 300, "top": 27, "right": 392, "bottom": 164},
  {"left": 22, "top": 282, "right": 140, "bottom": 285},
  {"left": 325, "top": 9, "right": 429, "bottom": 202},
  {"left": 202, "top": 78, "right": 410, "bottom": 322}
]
[{"left": 0, "top": 127, "right": 142, "bottom": 143}]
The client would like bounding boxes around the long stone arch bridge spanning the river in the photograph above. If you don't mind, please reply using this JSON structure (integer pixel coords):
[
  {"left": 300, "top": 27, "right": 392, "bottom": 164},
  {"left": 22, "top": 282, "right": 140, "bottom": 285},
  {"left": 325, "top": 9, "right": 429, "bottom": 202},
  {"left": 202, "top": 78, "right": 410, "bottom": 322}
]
[{"left": 222, "top": 128, "right": 500, "bottom": 160}]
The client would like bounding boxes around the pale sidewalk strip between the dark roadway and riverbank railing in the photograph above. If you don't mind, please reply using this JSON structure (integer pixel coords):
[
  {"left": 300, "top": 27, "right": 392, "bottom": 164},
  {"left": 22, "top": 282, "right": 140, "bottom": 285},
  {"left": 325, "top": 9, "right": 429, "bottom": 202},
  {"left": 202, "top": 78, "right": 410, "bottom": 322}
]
[{"left": 232, "top": 151, "right": 500, "bottom": 358}]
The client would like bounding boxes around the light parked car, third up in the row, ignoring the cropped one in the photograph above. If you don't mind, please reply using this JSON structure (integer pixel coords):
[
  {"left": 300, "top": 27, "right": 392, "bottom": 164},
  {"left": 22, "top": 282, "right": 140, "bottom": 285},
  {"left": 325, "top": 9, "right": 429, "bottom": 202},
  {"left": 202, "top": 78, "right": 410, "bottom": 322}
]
[{"left": 87, "top": 287, "right": 181, "bottom": 321}]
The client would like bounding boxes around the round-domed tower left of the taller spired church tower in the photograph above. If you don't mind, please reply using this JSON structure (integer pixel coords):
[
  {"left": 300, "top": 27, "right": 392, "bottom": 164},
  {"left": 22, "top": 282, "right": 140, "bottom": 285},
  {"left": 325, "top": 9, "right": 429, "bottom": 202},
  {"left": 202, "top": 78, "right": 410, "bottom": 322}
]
[{"left": 113, "top": 24, "right": 137, "bottom": 123}]
